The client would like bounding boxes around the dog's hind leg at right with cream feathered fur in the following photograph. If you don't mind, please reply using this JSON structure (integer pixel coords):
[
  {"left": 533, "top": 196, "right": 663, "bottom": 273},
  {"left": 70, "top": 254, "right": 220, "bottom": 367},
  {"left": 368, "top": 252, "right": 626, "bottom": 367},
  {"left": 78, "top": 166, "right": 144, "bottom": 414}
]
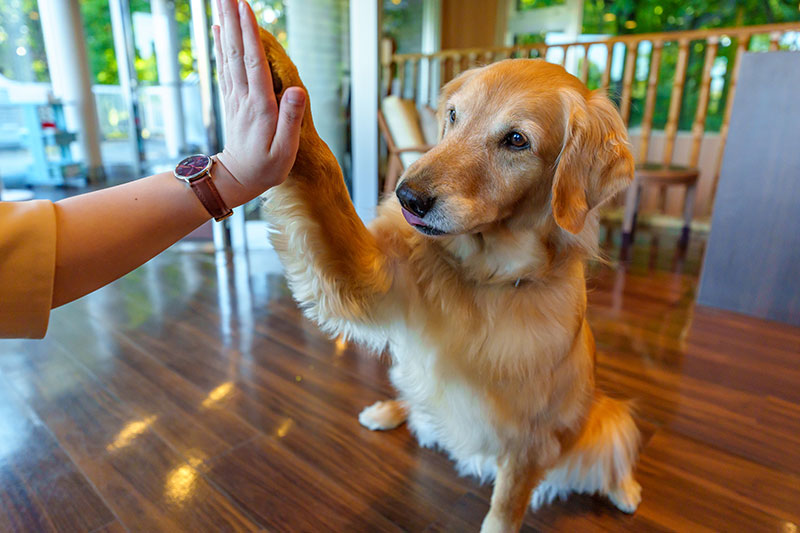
[{"left": 531, "top": 394, "right": 640, "bottom": 512}]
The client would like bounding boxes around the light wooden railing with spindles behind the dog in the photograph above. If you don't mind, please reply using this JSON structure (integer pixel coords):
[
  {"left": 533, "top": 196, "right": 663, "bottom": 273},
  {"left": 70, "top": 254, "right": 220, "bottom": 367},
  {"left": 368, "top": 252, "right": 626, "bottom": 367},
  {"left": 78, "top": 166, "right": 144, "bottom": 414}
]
[{"left": 381, "top": 23, "right": 800, "bottom": 215}]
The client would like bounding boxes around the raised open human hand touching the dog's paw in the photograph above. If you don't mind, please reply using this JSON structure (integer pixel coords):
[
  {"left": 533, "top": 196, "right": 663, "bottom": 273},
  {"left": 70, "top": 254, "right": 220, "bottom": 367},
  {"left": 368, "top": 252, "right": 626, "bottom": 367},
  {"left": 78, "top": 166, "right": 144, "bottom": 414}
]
[{"left": 212, "top": 0, "right": 306, "bottom": 207}]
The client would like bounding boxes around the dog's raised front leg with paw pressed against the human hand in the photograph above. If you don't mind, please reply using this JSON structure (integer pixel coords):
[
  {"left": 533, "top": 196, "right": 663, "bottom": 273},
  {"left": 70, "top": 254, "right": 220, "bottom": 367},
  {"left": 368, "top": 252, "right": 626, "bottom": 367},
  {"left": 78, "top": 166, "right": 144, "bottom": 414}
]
[{"left": 261, "top": 31, "right": 392, "bottom": 332}]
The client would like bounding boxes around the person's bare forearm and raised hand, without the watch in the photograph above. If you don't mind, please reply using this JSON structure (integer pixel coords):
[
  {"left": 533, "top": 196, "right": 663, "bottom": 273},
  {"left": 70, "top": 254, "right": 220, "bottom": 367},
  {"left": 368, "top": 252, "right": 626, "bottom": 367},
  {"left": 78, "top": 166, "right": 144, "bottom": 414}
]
[{"left": 52, "top": 0, "right": 305, "bottom": 307}]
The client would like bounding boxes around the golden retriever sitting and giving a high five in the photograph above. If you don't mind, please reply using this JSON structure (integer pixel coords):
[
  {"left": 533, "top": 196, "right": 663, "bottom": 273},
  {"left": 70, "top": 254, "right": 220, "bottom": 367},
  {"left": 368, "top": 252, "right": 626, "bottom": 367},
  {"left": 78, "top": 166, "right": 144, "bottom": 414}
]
[{"left": 262, "top": 32, "right": 641, "bottom": 532}]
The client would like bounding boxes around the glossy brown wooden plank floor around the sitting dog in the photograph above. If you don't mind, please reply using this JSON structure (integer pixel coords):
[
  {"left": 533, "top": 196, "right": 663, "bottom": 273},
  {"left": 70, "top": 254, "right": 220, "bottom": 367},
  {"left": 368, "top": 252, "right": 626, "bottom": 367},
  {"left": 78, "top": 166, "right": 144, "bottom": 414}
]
[{"left": 0, "top": 232, "right": 800, "bottom": 533}]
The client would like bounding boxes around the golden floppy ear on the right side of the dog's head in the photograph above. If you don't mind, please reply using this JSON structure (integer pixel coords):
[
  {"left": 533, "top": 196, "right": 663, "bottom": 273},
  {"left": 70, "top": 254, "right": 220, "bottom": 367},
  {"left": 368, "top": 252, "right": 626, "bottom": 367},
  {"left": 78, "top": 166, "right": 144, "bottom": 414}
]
[{"left": 551, "top": 91, "right": 634, "bottom": 233}]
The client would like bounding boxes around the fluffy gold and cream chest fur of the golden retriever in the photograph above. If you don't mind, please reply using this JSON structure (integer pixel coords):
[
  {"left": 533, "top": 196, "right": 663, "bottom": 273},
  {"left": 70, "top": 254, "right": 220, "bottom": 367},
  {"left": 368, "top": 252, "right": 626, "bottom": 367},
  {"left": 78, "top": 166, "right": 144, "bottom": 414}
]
[{"left": 378, "top": 247, "right": 585, "bottom": 479}]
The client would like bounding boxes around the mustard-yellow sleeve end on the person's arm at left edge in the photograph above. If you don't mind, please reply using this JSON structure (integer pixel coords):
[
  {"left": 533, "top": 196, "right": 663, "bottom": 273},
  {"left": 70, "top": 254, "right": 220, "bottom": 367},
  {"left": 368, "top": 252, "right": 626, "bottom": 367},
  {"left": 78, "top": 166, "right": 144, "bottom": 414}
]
[{"left": 0, "top": 200, "right": 56, "bottom": 339}]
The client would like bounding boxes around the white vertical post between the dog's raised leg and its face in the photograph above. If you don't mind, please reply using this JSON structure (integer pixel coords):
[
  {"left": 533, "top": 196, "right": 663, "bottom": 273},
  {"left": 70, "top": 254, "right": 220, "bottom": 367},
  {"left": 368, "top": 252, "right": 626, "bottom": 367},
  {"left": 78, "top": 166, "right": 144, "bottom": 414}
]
[{"left": 350, "top": 0, "right": 381, "bottom": 220}]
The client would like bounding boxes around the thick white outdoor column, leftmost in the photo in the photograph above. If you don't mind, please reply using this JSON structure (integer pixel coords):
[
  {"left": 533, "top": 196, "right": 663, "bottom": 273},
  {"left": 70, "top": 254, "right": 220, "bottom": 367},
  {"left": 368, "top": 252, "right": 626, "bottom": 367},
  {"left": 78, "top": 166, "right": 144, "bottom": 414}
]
[{"left": 39, "top": 0, "right": 103, "bottom": 181}]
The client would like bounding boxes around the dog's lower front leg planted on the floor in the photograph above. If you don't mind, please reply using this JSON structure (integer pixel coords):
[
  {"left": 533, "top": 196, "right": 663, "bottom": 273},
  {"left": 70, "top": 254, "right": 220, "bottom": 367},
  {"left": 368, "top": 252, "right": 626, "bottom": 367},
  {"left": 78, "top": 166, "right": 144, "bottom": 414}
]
[{"left": 481, "top": 452, "right": 542, "bottom": 533}]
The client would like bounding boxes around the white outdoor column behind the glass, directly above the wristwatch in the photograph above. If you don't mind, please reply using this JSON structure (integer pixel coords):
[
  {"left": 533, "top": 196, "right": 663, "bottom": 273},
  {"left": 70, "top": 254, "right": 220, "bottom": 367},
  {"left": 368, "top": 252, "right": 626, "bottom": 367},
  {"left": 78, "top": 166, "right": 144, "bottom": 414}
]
[{"left": 150, "top": 0, "right": 186, "bottom": 159}]
